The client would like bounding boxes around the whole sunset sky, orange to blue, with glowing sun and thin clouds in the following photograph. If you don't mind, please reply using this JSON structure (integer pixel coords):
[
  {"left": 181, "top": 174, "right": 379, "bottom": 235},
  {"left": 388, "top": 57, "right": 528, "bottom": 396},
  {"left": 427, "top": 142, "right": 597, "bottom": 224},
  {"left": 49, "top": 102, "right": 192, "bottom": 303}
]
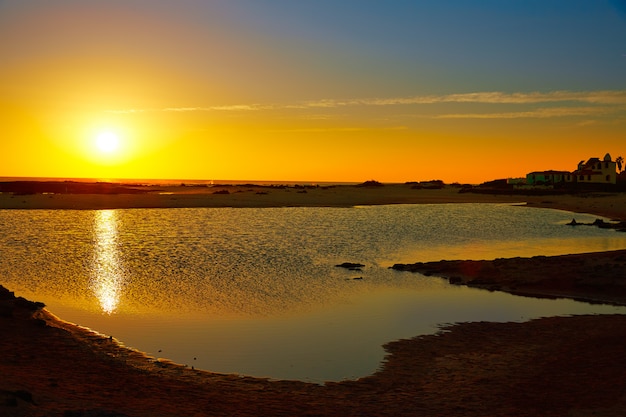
[{"left": 0, "top": 0, "right": 626, "bottom": 183}]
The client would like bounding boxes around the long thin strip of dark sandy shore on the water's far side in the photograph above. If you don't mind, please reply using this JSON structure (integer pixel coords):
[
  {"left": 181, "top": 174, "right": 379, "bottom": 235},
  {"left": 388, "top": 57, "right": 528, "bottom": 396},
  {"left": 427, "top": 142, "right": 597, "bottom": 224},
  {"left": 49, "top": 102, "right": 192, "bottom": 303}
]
[{"left": 0, "top": 183, "right": 626, "bottom": 221}]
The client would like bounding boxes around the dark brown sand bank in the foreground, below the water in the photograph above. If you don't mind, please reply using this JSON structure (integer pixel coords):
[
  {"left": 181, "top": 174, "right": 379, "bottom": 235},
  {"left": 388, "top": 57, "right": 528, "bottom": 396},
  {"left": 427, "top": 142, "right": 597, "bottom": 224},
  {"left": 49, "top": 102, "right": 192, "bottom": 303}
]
[{"left": 0, "top": 272, "right": 626, "bottom": 416}]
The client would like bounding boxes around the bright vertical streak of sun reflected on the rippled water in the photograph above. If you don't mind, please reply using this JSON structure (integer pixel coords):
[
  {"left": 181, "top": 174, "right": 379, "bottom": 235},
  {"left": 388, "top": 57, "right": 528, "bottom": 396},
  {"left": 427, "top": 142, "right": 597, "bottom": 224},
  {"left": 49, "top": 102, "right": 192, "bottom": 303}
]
[{"left": 91, "top": 210, "right": 123, "bottom": 314}]
